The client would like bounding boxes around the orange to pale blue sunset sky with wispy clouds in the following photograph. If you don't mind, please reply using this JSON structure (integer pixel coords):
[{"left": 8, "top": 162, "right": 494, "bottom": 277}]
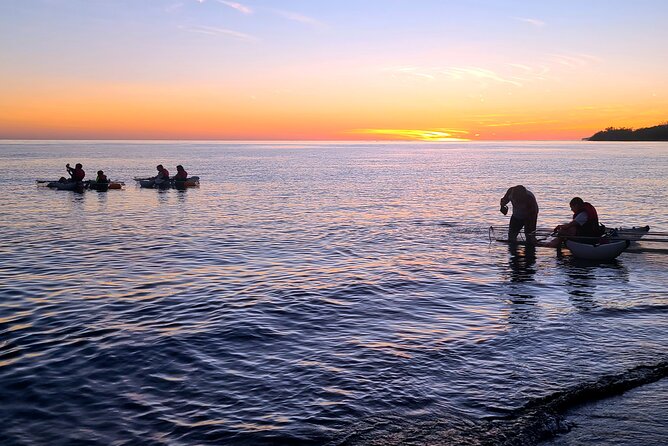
[{"left": 0, "top": 0, "right": 668, "bottom": 141}]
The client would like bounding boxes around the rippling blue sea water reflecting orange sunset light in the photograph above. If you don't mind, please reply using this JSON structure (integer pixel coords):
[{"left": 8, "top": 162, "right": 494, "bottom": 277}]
[{"left": 0, "top": 141, "right": 668, "bottom": 445}]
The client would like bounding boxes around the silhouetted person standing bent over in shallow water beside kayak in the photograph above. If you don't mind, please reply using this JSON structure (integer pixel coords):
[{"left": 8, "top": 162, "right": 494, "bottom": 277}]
[{"left": 500, "top": 184, "right": 538, "bottom": 244}]
